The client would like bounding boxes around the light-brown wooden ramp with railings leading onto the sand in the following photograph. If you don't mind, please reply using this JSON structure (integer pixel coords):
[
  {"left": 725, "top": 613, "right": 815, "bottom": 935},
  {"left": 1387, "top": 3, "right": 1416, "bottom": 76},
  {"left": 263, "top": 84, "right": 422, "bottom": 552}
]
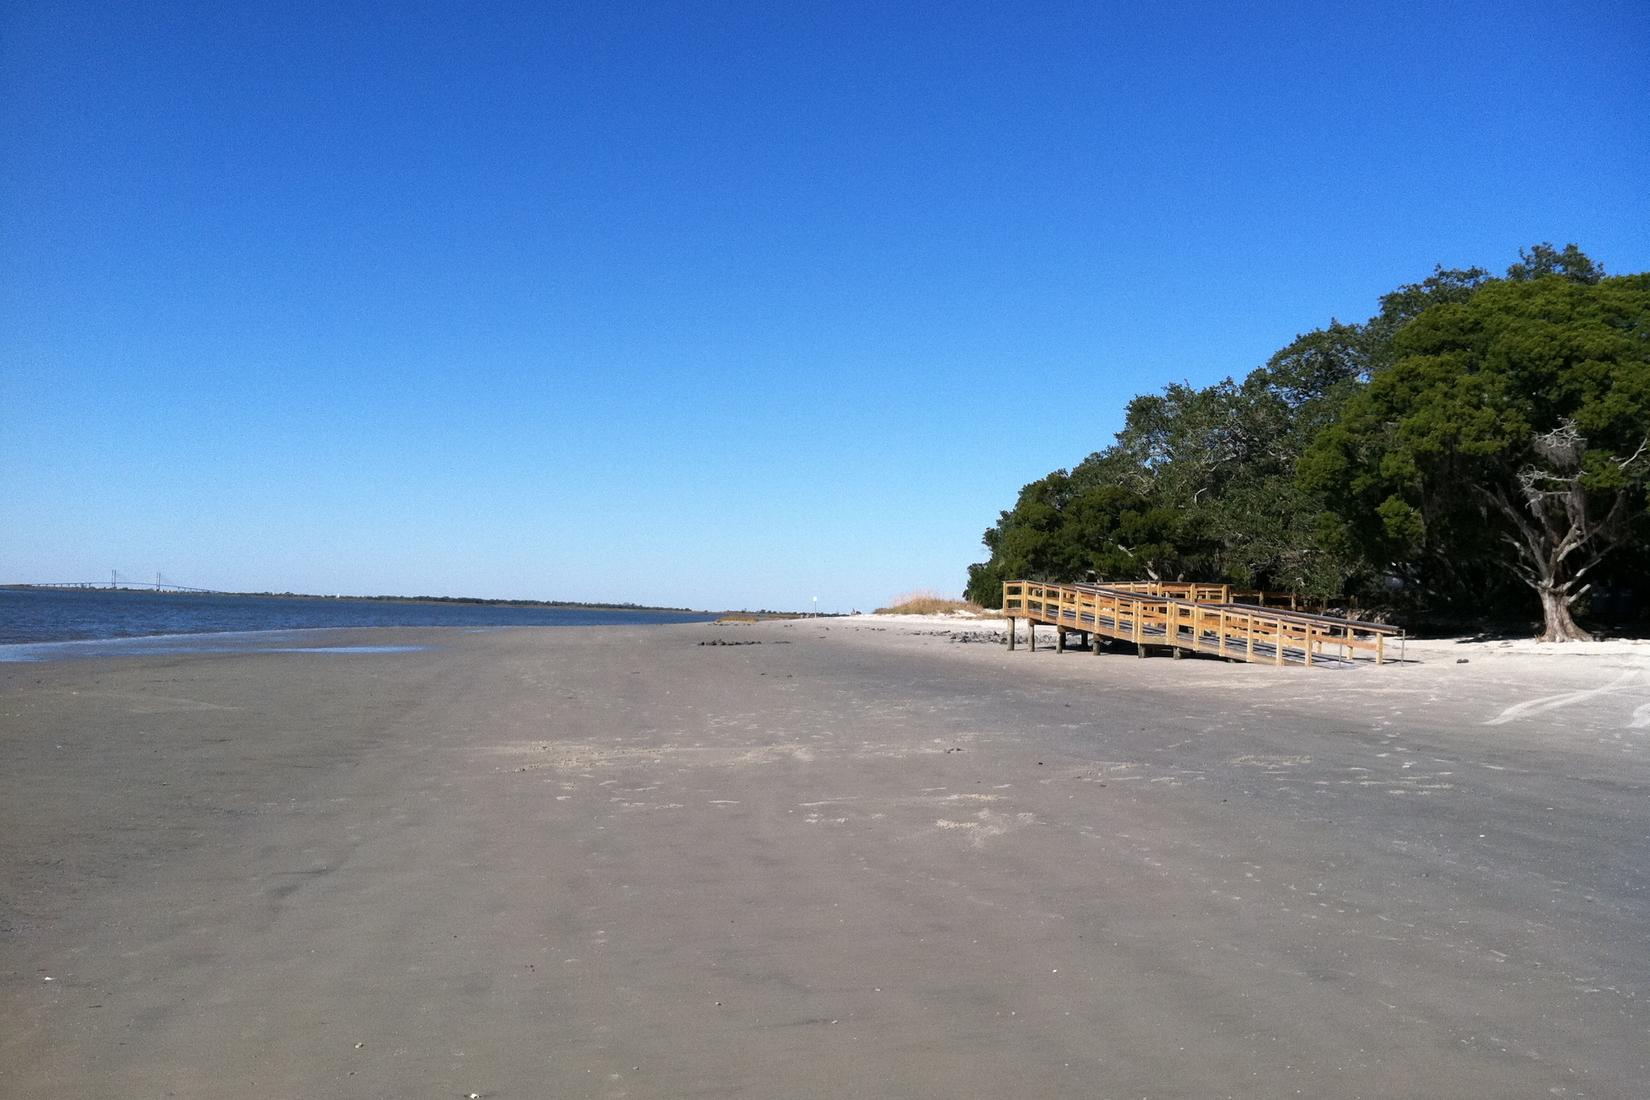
[{"left": 1003, "top": 581, "right": 1403, "bottom": 665}]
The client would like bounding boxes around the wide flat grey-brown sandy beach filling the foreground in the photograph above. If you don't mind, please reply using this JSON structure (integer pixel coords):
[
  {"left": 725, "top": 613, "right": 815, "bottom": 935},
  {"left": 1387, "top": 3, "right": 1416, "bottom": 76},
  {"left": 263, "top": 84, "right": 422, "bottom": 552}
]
[{"left": 0, "top": 617, "right": 1650, "bottom": 1100}]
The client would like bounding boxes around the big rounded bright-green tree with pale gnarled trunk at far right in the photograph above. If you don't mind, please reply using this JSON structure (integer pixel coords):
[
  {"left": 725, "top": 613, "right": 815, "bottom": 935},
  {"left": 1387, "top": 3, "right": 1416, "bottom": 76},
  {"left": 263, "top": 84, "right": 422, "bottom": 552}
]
[{"left": 1302, "top": 270, "right": 1650, "bottom": 640}]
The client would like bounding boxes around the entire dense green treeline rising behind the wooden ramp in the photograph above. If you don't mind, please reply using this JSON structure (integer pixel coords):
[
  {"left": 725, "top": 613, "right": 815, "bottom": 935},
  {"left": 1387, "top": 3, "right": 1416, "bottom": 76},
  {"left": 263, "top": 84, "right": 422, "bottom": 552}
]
[{"left": 967, "top": 244, "right": 1650, "bottom": 640}]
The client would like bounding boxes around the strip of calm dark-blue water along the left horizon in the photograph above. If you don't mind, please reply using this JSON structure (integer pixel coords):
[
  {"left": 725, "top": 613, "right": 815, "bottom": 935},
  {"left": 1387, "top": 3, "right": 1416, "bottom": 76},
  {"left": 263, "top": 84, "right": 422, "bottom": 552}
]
[{"left": 0, "top": 589, "right": 714, "bottom": 660}]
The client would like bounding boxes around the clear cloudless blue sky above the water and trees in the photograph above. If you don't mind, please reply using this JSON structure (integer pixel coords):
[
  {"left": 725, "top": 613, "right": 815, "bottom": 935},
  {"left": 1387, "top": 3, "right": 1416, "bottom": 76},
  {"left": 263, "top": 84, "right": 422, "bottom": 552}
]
[{"left": 0, "top": 0, "right": 1650, "bottom": 610}]
